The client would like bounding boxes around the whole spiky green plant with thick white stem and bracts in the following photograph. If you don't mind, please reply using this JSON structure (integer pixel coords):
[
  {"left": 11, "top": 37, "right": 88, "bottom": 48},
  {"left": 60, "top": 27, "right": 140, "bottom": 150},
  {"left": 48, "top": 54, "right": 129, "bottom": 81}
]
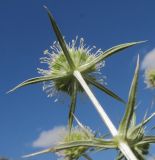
[{"left": 9, "top": 7, "right": 155, "bottom": 160}]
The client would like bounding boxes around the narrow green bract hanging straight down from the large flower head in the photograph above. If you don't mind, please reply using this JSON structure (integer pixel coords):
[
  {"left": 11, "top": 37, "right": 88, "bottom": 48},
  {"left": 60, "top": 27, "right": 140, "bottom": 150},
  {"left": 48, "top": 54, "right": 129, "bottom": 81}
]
[{"left": 68, "top": 81, "right": 77, "bottom": 131}]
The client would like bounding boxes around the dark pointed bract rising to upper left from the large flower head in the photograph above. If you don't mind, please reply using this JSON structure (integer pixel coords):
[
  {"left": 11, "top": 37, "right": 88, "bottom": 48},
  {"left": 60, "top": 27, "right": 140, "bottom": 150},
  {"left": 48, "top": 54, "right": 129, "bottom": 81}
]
[{"left": 44, "top": 6, "right": 75, "bottom": 69}]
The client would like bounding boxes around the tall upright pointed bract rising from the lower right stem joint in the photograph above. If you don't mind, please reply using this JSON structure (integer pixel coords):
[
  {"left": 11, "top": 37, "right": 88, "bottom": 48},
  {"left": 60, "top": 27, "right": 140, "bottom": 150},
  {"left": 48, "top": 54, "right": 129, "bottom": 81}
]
[{"left": 119, "top": 55, "right": 139, "bottom": 138}]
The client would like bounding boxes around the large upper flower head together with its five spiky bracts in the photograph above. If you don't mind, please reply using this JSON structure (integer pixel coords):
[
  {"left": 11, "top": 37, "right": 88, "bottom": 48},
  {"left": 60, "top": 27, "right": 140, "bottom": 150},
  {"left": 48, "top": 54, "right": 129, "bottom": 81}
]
[{"left": 10, "top": 7, "right": 143, "bottom": 130}]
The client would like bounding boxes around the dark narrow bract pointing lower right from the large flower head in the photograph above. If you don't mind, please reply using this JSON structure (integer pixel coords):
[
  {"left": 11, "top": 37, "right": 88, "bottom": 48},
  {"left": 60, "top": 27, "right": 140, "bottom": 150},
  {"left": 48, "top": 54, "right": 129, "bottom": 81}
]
[{"left": 84, "top": 76, "right": 126, "bottom": 104}]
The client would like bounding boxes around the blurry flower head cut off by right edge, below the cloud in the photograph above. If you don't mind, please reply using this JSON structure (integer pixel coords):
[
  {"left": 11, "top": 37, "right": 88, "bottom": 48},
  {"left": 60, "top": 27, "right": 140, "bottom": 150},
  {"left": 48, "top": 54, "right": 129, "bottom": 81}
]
[{"left": 145, "top": 69, "right": 155, "bottom": 89}]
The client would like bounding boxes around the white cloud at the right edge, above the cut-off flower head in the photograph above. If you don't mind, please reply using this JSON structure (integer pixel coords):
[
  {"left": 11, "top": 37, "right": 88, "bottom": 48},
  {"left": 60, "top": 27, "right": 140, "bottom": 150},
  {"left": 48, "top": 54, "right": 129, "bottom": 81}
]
[{"left": 141, "top": 48, "right": 155, "bottom": 70}]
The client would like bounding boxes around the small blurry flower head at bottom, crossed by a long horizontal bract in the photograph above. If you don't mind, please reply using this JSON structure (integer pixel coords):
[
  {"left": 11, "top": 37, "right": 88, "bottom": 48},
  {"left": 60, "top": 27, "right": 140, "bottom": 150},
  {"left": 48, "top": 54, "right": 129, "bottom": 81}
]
[{"left": 57, "top": 127, "right": 95, "bottom": 160}]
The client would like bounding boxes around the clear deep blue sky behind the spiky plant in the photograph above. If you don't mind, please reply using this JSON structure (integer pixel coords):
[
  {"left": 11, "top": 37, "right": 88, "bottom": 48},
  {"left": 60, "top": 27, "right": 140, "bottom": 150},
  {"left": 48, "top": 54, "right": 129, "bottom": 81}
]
[{"left": 0, "top": 0, "right": 155, "bottom": 160}]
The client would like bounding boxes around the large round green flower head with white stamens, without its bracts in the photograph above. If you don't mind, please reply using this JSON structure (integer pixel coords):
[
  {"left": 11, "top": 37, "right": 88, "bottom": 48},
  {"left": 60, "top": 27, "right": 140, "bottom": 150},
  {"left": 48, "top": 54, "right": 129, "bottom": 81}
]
[{"left": 38, "top": 38, "right": 104, "bottom": 96}]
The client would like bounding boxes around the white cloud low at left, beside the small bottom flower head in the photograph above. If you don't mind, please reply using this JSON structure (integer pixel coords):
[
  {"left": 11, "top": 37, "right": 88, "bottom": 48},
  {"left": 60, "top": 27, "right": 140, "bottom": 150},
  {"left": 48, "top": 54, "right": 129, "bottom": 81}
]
[{"left": 32, "top": 126, "right": 67, "bottom": 148}]
